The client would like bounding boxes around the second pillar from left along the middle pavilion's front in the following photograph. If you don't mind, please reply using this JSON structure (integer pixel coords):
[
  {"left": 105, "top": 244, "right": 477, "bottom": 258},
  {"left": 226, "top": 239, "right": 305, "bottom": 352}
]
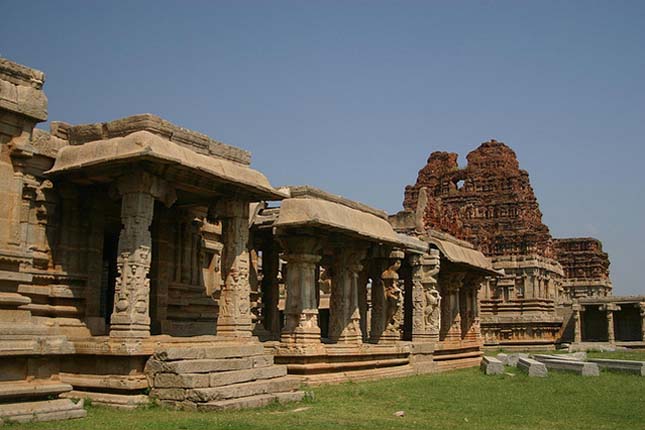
[{"left": 328, "top": 247, "right": 366, "bottom": 344}]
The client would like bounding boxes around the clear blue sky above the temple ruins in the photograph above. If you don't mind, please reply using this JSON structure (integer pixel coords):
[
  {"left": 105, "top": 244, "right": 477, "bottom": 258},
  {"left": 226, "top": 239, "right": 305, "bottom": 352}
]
[{"left": 0, "top": 0, "right": 645, "bottom": 294}]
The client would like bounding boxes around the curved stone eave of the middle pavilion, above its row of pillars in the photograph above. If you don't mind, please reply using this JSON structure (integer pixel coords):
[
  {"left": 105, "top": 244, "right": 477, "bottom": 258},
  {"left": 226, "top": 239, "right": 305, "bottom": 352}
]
[{"left": 274, "top": 197, "right": 404, "bottom": 247}]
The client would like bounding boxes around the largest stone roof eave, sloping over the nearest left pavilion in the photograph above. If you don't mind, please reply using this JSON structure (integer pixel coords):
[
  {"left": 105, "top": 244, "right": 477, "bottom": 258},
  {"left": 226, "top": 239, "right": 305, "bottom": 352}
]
[{"left": 46, "top": 131, "right": 288, "bottom": 200}]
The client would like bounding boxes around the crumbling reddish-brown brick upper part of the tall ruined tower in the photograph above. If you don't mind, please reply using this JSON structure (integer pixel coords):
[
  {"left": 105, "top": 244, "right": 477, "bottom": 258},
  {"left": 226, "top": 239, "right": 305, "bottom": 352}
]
[{"left": 403, "top": 140, "right": 554, "bottom": 258}]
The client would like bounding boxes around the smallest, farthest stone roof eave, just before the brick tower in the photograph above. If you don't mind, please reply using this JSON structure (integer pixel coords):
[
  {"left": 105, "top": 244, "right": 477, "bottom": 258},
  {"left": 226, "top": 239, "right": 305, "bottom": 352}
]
[{"left": 427, "top": 232, "right": 504, "bottom": 276}]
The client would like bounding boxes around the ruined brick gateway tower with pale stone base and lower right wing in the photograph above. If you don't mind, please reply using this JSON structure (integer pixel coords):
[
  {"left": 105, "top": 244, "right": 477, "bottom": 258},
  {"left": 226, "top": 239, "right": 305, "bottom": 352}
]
[{"left": 403, "top": 140, "right": 611, "bottom": 348}]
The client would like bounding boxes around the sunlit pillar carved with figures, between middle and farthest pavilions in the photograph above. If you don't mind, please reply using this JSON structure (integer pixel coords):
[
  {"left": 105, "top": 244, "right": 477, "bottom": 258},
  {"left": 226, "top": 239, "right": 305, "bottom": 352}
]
[{"left": 409, "top": 250, "right": 441, "bottom": 341}]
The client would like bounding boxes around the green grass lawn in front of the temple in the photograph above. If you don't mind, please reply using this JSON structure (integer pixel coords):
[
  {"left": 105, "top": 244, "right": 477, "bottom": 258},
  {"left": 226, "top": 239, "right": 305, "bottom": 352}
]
[{"left": 16, "top": 358, "right": 645, "bottom": 430}]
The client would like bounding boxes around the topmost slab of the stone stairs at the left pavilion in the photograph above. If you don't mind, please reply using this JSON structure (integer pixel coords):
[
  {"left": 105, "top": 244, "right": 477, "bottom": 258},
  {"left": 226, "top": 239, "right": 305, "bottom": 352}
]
[{"left": 154, "top": 343, "right": 264, "bottom": 361}]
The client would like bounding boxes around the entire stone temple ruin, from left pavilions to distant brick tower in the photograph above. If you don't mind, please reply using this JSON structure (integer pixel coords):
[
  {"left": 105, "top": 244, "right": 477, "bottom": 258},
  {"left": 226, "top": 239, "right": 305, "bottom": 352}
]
[{"left": 0, "top": 54, "right": 645, "bottom": 421}]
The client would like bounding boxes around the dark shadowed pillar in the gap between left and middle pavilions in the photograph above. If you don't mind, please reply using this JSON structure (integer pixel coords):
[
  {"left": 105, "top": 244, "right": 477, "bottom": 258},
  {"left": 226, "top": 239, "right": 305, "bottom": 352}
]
[{"left": 262, "top": 241, "right": 280, "bottom": 336}]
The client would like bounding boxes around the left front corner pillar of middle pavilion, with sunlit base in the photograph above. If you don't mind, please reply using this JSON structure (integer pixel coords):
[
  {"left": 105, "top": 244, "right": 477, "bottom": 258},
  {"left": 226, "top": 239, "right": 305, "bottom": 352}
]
[{"left": 280, "top": 235, "right": 321, "bottom": 346}]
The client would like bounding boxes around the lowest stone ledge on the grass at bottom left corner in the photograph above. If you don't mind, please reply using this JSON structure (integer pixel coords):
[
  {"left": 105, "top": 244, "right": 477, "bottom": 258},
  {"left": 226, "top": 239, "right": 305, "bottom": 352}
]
[{"left": 0, "top": 399, "right": 87, "bottom": 424}]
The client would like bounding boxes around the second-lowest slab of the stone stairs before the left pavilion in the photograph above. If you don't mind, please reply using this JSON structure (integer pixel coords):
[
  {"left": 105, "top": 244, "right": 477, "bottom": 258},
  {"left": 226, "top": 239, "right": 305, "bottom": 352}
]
[{"left": 186, "top": 376, "right": 302, "bottom": 403}]
